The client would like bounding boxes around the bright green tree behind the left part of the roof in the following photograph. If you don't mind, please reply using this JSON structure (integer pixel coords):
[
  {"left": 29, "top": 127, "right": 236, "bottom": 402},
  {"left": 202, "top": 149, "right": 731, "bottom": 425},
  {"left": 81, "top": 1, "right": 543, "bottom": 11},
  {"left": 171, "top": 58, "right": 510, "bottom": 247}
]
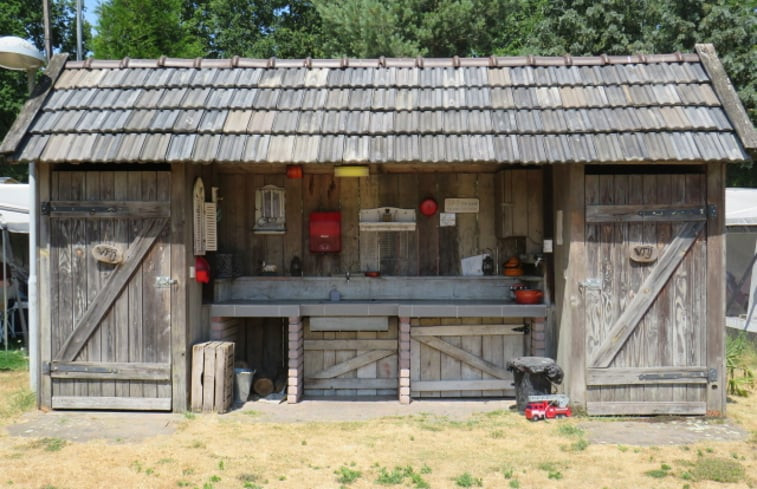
[{"left": 93, "top": 0, "right": 204, "bottom": 59}]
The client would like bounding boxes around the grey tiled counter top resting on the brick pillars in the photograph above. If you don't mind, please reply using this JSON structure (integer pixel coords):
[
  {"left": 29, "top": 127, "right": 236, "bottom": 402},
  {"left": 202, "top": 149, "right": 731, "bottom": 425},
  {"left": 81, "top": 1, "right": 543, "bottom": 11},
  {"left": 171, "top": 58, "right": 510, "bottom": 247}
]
[{"left": 210, "top": 300, "right": 547, "bottom": 318}]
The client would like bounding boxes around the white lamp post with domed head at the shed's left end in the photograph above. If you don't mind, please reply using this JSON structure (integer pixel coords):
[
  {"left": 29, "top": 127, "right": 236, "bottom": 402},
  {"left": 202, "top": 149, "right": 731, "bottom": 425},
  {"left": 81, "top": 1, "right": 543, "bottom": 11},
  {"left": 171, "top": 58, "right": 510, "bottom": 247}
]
[{"left": 0, "top": 34, "right": 46, "bottom": 392}]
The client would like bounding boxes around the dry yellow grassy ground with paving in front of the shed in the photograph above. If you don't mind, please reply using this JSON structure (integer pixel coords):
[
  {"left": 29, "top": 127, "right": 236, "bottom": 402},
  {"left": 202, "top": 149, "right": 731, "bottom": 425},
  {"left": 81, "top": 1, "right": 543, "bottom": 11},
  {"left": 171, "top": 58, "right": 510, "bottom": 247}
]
[{"left": 0, "top": 373, "right": 757, "bottom": 489}]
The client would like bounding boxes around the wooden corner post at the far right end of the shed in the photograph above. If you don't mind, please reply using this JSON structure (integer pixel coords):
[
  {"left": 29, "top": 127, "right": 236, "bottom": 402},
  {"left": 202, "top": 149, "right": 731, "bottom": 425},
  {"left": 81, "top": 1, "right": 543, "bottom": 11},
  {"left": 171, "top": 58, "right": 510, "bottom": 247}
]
[{"left": 706, "top": 163, "right": 726, "bottom": 416}]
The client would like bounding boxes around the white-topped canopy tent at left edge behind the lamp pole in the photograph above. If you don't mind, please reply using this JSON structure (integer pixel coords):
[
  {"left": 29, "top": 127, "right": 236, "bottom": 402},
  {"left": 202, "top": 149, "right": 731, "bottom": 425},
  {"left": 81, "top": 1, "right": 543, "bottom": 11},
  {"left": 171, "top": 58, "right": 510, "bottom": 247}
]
[{"left": 0, "top": 183, "right": 30, "bottom": 348}]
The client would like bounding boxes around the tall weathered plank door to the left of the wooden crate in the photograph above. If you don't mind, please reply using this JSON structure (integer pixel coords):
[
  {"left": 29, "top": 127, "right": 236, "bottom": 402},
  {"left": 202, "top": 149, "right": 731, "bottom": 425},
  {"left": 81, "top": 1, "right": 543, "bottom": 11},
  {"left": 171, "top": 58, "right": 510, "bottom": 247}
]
[{"left": 42, "top": 171, "right": 172, "bottom": 410}]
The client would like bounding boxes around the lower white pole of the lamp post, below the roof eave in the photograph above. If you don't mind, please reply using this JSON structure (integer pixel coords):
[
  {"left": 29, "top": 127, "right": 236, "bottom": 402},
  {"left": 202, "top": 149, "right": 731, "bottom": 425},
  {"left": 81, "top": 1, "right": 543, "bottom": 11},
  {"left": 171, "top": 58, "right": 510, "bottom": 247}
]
[{"left": 28, "top": 163, "right": 40, "bottom": 392}]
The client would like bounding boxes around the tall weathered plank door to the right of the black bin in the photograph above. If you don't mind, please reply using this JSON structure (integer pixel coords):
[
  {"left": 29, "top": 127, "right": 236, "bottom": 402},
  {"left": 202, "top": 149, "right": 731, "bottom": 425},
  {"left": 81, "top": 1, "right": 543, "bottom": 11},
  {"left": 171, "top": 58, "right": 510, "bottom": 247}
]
[{"left": 581, "top": 172, "right": 711, "bottom": 414}]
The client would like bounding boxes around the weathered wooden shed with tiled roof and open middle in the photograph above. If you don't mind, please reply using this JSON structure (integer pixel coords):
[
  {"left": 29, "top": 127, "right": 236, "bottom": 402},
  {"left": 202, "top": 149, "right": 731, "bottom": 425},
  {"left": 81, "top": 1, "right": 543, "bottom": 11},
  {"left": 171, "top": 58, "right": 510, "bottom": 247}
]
[{"left": 0, "top": 45, "right": 757, "bottom": 414}]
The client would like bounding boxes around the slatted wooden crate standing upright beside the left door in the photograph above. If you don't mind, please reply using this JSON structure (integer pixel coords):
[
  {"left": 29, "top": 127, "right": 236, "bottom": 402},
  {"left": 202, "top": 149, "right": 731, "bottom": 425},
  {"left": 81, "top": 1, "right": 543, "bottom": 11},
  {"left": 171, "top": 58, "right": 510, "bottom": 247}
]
[{"left": 192, "top": 341, "right": 234, "bottom": 413}]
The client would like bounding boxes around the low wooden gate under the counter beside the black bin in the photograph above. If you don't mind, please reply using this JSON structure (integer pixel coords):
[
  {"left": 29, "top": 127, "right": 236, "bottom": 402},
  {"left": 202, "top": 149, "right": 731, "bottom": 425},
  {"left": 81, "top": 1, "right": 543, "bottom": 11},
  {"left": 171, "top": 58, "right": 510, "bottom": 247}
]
[{"left": 410, "top": 318, "right": 526, "bottom": 398}]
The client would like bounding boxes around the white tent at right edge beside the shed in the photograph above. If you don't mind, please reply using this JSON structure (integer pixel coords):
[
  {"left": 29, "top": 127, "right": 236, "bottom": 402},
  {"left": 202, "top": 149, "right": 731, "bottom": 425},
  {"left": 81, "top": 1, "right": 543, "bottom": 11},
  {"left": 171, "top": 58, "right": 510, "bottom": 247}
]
[{"left": 725, "top": 188, "right": 757, "bottom": 332}]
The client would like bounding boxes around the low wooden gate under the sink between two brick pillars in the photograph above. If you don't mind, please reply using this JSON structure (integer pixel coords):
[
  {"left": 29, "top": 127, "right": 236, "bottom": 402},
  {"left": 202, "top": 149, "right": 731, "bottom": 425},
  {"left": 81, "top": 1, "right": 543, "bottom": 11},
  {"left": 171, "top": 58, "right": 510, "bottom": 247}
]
[{"left": 304, "top": 317, "right": 399, "bottom": 398}]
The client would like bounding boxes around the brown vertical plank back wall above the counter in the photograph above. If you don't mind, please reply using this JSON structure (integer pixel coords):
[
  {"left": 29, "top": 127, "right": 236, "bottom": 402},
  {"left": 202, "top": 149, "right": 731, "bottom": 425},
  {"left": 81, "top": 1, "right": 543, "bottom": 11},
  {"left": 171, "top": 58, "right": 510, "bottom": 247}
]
[{"left": 215, "top": 170, "right": 532, "bottom": 276}]
